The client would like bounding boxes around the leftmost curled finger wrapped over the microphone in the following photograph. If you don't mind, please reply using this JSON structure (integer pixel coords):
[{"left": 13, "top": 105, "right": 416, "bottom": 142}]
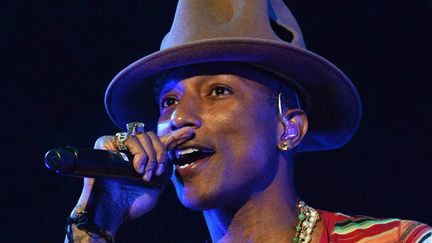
[{"left": 124, "top": 136, "right": 149, "bottom": 174}]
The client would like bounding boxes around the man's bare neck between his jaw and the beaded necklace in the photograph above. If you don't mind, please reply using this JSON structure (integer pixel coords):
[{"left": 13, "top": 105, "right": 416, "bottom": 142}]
[{"left": 204, "top": 157, "right": 298, "bottom": 242}]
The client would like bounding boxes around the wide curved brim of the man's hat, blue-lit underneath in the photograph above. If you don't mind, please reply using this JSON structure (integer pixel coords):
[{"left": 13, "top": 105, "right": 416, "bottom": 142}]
[{"left": 105, "top": 38, "right": 361, "bottom": 151}]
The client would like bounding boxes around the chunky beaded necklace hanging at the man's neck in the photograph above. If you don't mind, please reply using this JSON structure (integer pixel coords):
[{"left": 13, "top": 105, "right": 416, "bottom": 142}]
[{"left": 292, "top": 201, "right": 320, "bottom": 243}]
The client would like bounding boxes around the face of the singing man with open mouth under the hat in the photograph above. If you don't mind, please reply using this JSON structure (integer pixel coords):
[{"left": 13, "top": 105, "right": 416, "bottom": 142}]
[{"left": 158, "top": 64, "right": 278, "bottom": 210}]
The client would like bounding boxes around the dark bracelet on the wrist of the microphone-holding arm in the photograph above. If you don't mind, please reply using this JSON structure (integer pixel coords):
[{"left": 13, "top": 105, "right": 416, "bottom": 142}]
[{"left": 65, "top": 211, "right": 114, "bottom": 243}]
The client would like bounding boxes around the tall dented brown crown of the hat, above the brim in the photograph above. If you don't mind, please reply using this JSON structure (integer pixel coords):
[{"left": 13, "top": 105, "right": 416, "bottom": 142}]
[{"left": 160, "top": 0, "right": 305, "bottom": 50}]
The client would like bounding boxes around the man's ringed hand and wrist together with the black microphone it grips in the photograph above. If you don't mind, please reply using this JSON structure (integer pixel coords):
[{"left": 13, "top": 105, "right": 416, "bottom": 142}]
[{"left": 45, "top": 121, "right": 193, "bottom": 235}]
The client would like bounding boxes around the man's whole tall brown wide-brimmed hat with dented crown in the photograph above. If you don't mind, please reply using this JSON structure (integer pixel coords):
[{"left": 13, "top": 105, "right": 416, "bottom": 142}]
[{"left": 105, "top": 0, "right": 361, "bottom": 151}]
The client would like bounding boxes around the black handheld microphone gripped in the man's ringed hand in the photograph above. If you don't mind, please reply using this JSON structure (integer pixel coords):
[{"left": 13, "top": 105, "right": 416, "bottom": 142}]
[{"left": 45, "top": 146, "right": 173, "bottom": 187}]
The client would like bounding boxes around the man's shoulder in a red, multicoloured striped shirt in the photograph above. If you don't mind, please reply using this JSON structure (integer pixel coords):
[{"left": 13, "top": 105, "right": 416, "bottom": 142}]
[{"left": 321, "top": 211, "right": 432, "bottom": 242}]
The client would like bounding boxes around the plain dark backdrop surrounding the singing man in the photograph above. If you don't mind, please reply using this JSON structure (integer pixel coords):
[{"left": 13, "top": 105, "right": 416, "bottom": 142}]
[{"left": 0, "top": 0, "right": 432, "bottom": 242}]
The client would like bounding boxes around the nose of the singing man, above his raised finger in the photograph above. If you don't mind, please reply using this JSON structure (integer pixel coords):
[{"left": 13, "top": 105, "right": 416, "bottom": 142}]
[{"left": 170, "top": 95, "right": 202, "bottom": 131}]
